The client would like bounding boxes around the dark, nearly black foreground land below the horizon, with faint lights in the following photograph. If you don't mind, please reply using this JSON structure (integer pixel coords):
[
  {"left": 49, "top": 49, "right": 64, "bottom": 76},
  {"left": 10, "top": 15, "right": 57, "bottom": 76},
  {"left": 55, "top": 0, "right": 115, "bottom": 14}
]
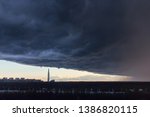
[{"left": 0, "top": 82, "right": 150, "bottom": 100}]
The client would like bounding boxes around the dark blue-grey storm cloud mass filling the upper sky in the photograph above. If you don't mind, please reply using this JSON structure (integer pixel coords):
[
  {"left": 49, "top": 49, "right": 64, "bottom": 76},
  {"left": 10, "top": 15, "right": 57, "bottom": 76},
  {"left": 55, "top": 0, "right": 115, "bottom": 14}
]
[{"left": 0, "top": 0, "right": 150, "bottom": 79}]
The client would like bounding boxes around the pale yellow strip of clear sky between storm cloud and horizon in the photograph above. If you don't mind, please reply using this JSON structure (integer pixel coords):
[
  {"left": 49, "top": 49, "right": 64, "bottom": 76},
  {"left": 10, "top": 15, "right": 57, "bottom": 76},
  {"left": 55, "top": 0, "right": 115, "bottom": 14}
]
[{"left": 0, "top": 60, "right": 129, "bottom": 81}]
